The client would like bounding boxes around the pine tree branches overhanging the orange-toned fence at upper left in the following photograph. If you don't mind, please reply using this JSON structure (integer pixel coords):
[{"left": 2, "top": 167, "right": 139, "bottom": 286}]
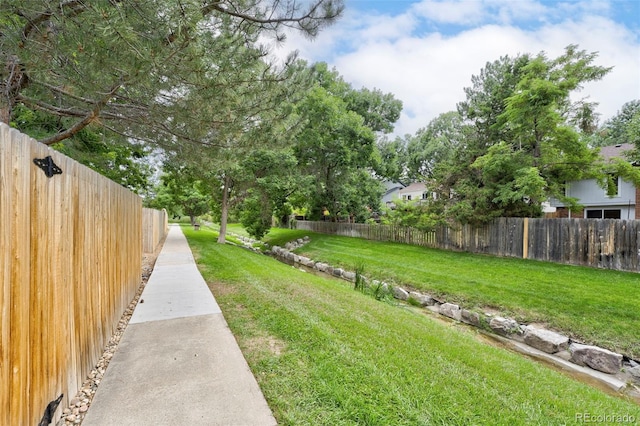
[{"left": 0, "top": 0, "right": 343, "bottom": 144}]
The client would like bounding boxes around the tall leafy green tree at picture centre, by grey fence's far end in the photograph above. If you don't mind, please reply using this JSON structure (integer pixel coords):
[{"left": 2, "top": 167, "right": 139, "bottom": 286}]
[{"left": 295, "top": 63, "right": 402, "bottom": 221}]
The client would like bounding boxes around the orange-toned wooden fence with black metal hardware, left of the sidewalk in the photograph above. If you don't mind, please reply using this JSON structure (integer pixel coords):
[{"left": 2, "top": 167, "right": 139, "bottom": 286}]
[{"left": 0, "top": 123, "right": 142, "bottom": 425}]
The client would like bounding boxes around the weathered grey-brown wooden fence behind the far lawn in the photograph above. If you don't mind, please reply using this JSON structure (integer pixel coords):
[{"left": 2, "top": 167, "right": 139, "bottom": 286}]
[{"left": 296, "top": 218, "right": 640, "bottom": 272}]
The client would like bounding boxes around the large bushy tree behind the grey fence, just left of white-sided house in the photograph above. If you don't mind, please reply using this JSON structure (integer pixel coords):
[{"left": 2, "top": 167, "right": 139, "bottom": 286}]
[{"left": 413, "top": 46, "right": 610, "bottom": 223}]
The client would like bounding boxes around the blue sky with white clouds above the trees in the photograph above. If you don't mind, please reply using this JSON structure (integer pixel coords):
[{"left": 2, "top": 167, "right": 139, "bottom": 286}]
[{"left": 277, "top": 0, "right": 640, "bottom": 135}]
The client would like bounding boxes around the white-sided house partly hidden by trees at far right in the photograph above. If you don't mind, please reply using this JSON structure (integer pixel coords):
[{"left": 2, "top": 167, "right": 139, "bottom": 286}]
[{"left": 551, "top": 144, "right": 640, "bottom": 219}]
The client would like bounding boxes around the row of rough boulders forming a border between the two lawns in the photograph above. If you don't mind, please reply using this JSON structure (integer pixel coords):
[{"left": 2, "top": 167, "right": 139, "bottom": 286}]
[{"left": 239, "top": 236, "right": 640, "bottom": 393}]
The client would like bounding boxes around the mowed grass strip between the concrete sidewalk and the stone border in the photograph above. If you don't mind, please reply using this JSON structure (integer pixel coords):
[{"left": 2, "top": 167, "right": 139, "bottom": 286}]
[{"left": 183, "top": 227, "right": 640, "bottom": 425}]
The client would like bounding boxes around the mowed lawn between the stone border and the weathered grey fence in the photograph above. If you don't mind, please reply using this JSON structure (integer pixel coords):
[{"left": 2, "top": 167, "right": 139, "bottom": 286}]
[{"left": 265, "top": 229, "right": 640, "bottom": 359}]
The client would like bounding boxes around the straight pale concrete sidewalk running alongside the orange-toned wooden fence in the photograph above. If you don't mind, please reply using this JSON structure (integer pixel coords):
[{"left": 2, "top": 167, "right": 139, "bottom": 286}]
[{"left": 82, "top": 225, "right": 276, "bottom": 426}]
